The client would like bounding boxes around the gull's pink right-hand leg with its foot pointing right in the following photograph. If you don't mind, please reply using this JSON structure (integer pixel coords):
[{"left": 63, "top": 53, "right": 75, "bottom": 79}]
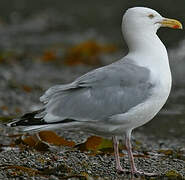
[{"left": 125, "top": 131, "right": 157, "bottom": 176}]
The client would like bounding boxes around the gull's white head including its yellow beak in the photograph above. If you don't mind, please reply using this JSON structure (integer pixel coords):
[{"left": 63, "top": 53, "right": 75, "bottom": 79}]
[{"left": 122, "top": 7, "right": 182, "bottom": 51}]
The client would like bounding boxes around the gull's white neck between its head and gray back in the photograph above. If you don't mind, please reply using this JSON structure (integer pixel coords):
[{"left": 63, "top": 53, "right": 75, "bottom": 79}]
[{"left": 123, "top": 31, "right": 169, "bottom": 68}]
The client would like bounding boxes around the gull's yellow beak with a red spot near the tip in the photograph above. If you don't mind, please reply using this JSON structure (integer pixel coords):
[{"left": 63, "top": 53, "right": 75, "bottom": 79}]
[{"left": 159, "top": 18, "right": 183, "bottom": 29}]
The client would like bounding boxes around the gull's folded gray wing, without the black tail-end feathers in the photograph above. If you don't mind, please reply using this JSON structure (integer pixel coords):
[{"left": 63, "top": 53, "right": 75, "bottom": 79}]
[{"left": 38, "top": 61, "right": 152, "bottom": 122}]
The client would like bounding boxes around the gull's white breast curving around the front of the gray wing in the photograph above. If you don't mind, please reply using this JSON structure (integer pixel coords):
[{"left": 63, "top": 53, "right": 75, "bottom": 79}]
[{"left": 108, "top": 39, "right": 172, "bottom": 134}]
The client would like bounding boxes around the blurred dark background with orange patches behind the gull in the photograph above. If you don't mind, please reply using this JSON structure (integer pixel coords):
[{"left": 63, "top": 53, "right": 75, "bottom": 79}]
[{"left": 0, "top": 0, "right": 185, "bottom": 142}]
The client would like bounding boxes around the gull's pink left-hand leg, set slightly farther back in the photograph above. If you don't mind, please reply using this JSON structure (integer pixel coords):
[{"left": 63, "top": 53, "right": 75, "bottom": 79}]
[{"left": 112, "top": 136, "right": 124, "bottom": 172}]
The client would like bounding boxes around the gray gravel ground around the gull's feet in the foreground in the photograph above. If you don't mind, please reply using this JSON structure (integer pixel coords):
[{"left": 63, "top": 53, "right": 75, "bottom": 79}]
[{"left": 0, "top": 129, "right": 185, "bottom": 180}]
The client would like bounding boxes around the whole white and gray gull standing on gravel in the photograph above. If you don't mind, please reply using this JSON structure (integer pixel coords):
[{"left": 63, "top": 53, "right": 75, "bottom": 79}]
[{"left": 8, "top": 7, "right": 182, "bottom": 176}]
